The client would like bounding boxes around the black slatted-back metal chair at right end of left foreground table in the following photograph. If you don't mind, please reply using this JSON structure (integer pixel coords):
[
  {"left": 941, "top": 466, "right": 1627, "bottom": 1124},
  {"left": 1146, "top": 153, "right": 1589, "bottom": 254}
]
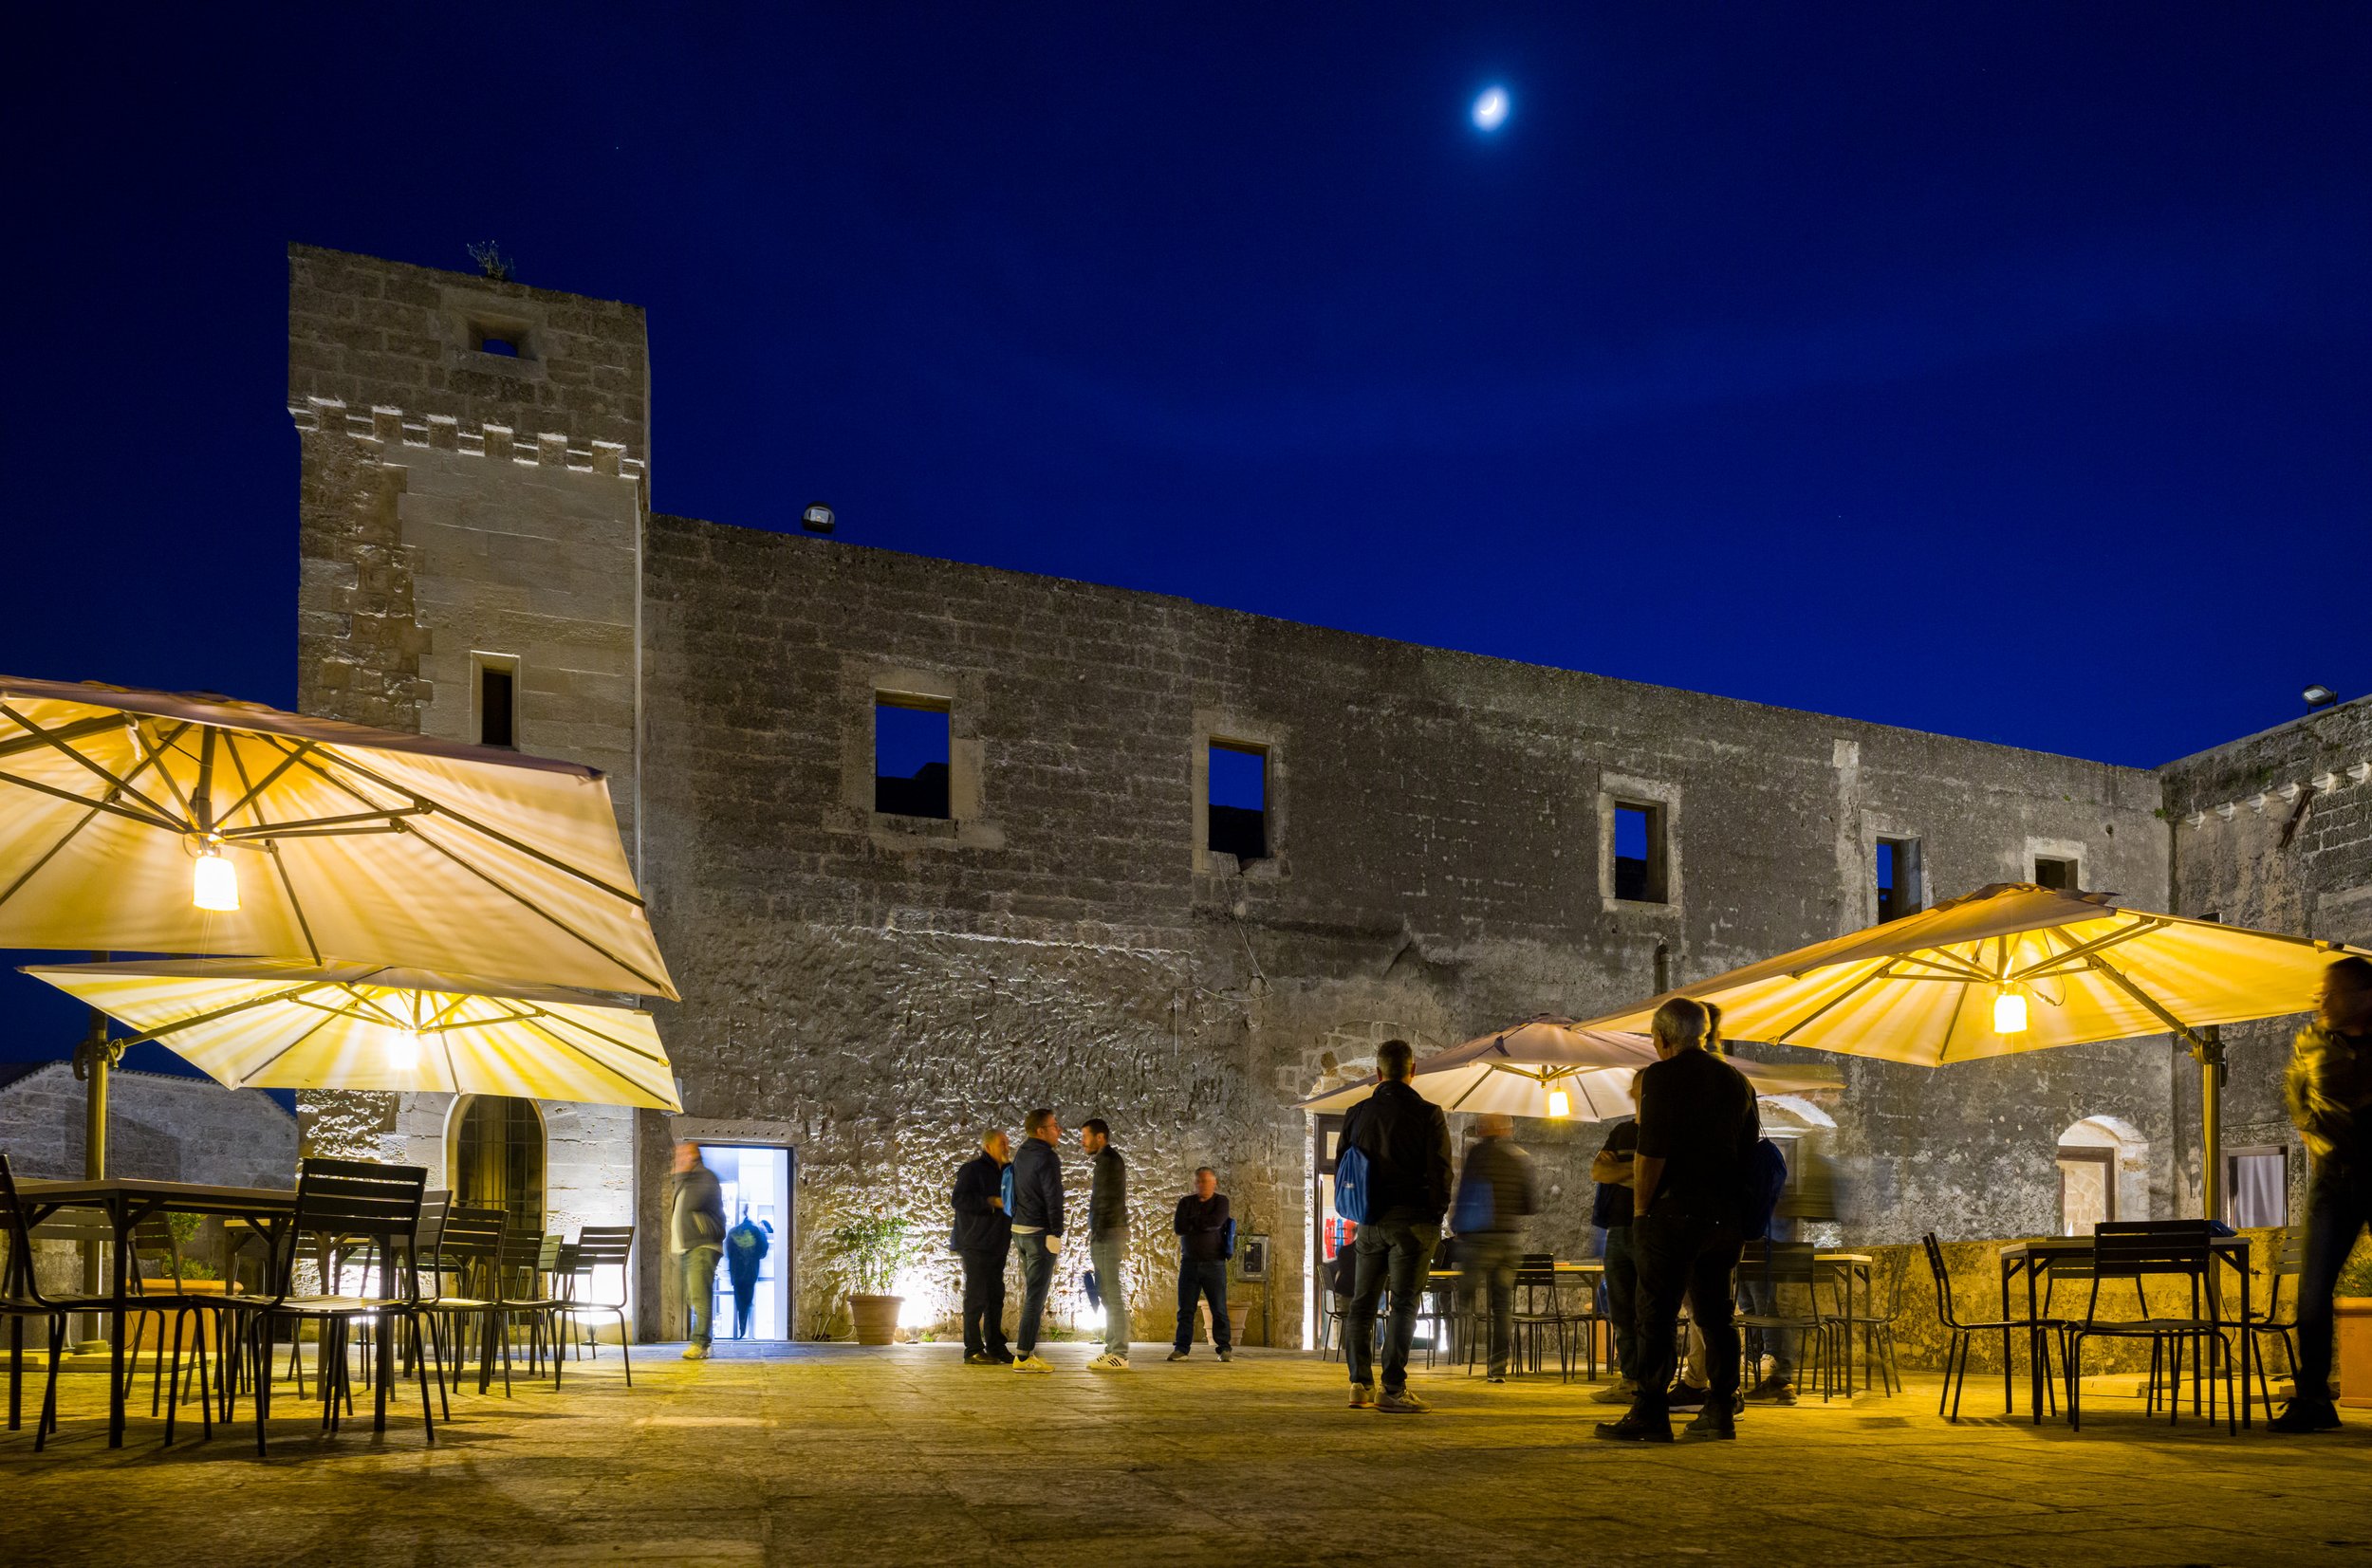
[{"left": 228, "top": 1160, "right": 436, "bottom": 1454}]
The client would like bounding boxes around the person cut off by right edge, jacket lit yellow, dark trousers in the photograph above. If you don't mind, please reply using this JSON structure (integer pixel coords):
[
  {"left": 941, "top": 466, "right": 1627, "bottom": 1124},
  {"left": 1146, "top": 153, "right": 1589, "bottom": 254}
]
[{"left": 2266, "top": 953, "right": 2372, "bottom": 1432}]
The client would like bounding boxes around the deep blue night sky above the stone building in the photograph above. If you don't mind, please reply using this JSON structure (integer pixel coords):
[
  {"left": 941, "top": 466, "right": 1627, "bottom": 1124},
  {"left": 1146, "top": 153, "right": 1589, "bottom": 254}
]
[{"left": 0, "top": 3, "right": 2372, "bottom": 1056}]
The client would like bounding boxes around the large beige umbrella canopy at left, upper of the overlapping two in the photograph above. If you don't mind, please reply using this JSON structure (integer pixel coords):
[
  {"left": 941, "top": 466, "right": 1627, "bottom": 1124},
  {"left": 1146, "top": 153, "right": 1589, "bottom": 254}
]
[{"left": 0, "top": 676, "right": 676, "bottom": 996}]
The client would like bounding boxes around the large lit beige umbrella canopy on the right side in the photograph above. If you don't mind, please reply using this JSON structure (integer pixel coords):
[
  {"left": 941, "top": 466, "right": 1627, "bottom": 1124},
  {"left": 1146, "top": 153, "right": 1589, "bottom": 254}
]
[{"left": 1584, "top": 882, "right": 2358, "bottom": 1067}]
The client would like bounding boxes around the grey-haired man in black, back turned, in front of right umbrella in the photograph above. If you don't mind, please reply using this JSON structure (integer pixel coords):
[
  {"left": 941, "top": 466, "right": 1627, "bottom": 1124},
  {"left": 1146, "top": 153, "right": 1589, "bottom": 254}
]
[{"left": 1599, "top": 996, "right": 1763, "bottom": 1442}]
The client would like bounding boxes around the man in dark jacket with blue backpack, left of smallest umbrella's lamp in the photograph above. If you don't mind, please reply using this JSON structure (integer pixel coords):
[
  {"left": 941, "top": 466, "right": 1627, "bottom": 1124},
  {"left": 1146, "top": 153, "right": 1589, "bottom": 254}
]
[{"left": 1336, "top": 1039, "right": 1450, "bottom": 1416}]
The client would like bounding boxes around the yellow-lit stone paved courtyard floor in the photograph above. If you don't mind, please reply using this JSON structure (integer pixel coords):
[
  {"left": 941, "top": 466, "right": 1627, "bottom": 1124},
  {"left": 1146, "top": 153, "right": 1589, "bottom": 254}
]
[{"left": 0, "top": 1345, "right": 2372, "bottom": 1568}]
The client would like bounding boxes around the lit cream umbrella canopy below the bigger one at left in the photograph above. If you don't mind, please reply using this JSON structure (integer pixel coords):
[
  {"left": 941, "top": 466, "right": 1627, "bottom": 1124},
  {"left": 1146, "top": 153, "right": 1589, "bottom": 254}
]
[{"left": 24, "top": 958, "right": 683, "bottom": 1110}]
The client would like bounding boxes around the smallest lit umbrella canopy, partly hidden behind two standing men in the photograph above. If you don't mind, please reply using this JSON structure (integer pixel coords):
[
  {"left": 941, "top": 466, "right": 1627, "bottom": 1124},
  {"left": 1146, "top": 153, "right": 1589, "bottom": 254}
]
[{"left": 1300, "top": 1018, "right": 1841, "bottom": 1122}]
